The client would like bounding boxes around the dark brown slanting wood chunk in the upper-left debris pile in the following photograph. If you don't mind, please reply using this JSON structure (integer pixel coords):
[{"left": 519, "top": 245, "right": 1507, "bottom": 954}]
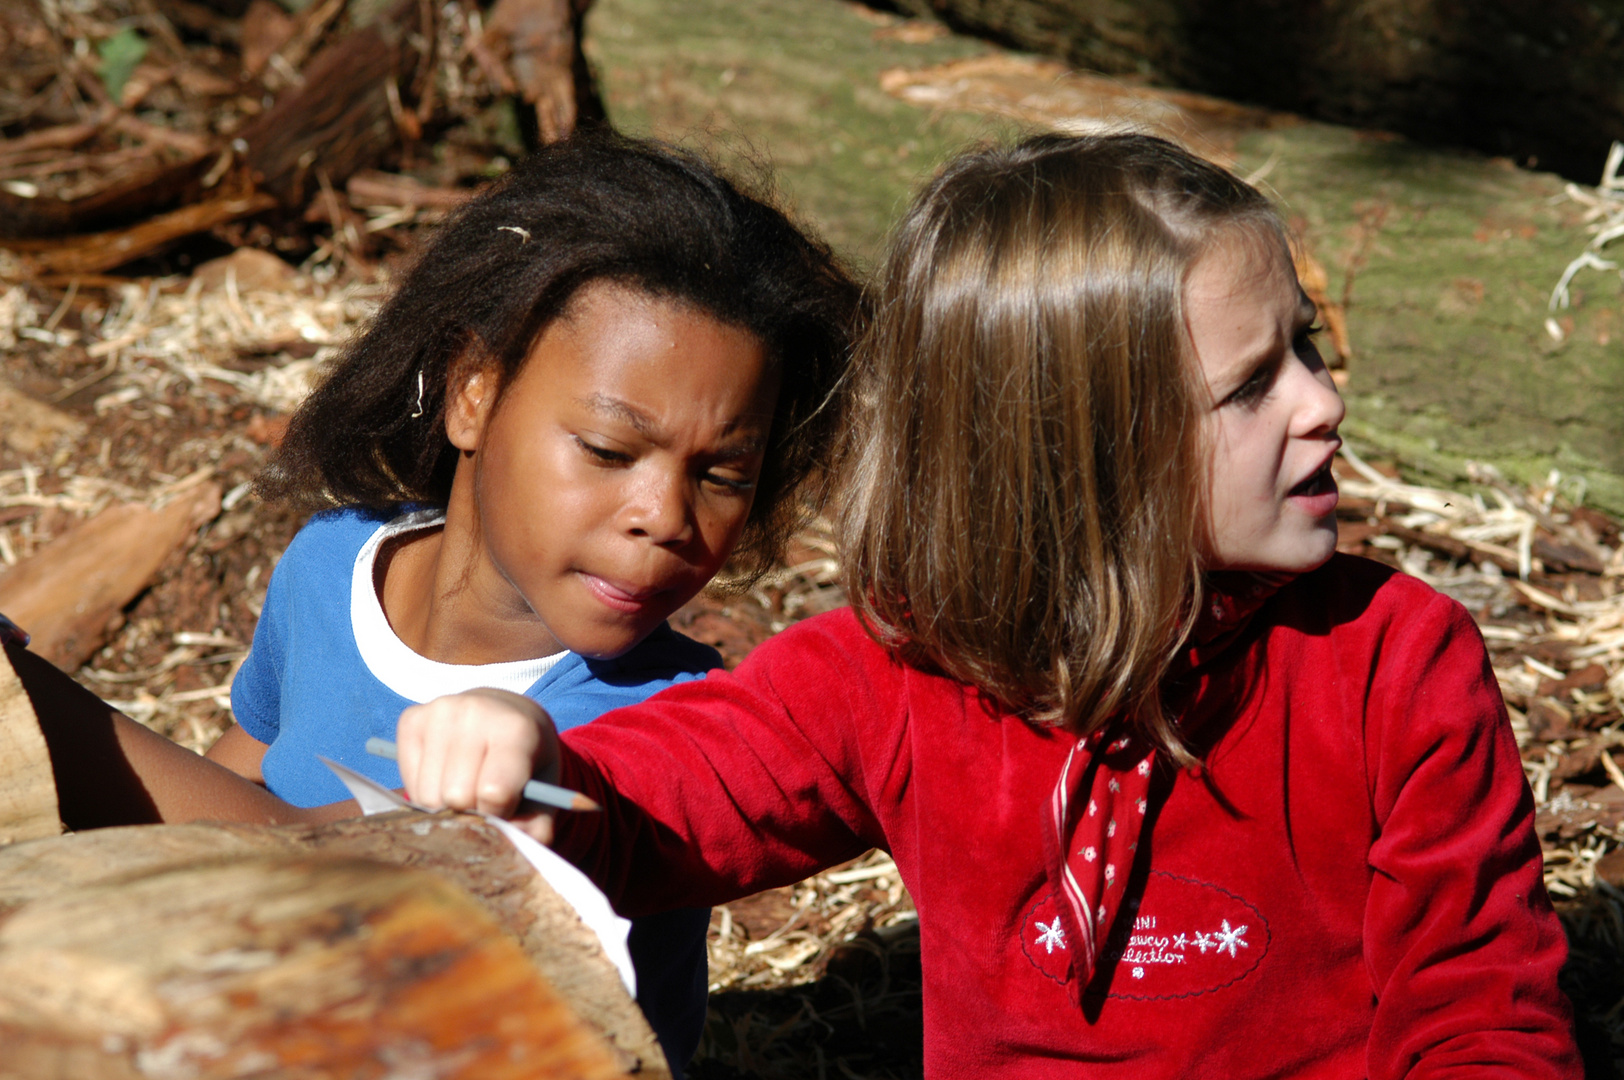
[{"left": 240, "top": 0, "right": 434, "bottom": 208}]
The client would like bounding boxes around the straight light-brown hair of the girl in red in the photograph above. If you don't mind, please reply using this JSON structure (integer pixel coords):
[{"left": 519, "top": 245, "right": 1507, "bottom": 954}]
[{"left": 840, "top": 135, "right": 1285, "bottom": 762}]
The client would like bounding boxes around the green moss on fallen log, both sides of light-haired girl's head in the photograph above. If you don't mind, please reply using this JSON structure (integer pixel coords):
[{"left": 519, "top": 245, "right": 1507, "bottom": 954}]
[{"left": 586, "top": 0, "right": 1624, "bottom": 513}]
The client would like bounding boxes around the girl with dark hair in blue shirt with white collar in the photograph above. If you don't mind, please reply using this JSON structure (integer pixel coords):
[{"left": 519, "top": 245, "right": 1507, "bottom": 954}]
[{"left": 209, "top": 135, "right": 857, "bottom": 1067}]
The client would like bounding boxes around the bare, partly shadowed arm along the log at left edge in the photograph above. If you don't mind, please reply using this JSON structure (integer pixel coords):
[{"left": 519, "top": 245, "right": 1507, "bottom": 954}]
[{"left": 5, "top": 645, "right": 359, "bottom": 830}]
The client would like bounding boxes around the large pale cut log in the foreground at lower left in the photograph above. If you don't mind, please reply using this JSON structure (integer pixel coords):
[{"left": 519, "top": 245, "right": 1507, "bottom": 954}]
[{"left": 0, "top": 651, "right": 669, "bottom": 1080}]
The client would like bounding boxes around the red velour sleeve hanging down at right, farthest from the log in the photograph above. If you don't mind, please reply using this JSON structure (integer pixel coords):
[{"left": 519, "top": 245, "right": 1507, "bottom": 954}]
[{"left": 1364, "top": 584, "right": 1583, "bottom": 1080}]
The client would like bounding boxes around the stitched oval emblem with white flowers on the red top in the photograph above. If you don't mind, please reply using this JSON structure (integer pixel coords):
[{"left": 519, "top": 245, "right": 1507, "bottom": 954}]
[{"left": 1021, "top": 870, "right": 1270, "bottom": 1000}]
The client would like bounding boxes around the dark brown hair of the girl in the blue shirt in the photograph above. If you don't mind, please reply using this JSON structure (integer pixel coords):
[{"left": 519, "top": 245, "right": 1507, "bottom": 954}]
[{"left": 258, "top": 132, "right": 859, "bottom": 581}]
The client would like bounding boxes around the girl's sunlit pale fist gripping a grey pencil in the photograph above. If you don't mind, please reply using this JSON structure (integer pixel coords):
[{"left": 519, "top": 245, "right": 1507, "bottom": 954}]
[{"left": 395, "top": 689, "right": 559, "bottom": 843}]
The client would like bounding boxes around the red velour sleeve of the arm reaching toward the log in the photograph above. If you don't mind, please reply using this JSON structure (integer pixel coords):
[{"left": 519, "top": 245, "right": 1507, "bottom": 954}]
[{"left": 554, "top": 612, "right": 908, "bottom": 916}]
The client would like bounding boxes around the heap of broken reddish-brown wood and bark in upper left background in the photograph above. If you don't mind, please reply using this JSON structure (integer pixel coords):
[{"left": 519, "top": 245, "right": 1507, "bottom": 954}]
[{"left": 0, "top": 0, "right": 598, "bottom": 274}]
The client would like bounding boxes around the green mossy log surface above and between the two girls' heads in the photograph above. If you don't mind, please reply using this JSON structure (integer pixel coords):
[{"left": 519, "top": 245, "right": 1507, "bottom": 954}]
[{"left": 585, "top": 0, "right": 1015, "bottom": 266}]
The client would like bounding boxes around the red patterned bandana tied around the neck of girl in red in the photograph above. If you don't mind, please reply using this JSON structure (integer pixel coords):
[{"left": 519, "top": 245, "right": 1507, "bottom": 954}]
[{"left": 1049, "top": 575, "right": 1283, "bottom": 996}]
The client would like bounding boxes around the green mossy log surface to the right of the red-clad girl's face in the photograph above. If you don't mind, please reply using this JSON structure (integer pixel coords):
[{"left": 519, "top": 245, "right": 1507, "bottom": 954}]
[{"left": 1241, "top": 125, "right": 1624, "bottom": 512}]
